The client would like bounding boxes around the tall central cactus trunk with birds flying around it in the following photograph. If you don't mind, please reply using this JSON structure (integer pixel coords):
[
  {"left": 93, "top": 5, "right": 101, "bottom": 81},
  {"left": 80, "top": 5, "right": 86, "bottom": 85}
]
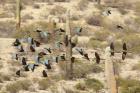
[{"left": 66, "top": 10, "right": 73, "bottom": 79}]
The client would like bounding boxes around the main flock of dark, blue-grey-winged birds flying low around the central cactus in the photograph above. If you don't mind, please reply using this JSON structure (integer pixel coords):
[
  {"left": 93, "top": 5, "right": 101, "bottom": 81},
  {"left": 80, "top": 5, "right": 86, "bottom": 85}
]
[{"left": 10, "top": 28, "right": 127, "bottom": 77}]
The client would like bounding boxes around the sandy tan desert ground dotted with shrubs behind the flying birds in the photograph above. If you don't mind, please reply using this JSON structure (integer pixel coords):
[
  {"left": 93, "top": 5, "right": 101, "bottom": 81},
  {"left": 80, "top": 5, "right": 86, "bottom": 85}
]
[{"left": 0, "top": 0, "right": 140, "bottom": 93}]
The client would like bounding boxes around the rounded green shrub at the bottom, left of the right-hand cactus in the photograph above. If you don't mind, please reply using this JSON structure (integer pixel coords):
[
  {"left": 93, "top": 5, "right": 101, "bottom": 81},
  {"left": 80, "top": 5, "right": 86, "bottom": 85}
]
[{"left": 85, "top": 78, "right": 104, "bottom": 92}]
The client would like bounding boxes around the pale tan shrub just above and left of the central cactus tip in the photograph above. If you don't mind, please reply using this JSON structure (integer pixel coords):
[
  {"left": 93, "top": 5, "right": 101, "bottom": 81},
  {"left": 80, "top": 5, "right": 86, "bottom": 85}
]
[{"left": 50, "top": 5, "right": 66, "bottom": 15}]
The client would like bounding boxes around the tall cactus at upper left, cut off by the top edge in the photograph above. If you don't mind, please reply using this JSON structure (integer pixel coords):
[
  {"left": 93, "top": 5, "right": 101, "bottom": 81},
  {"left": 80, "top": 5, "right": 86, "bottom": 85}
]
[{"left": 16, "top": 0, "right": 21, "bottom": 31}]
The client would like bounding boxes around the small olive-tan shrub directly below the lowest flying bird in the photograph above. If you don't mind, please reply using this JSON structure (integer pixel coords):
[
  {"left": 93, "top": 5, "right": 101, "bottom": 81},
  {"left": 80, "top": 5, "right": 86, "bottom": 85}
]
[{"left": 38, "top": 79, "right": 53, "bottom": 90}]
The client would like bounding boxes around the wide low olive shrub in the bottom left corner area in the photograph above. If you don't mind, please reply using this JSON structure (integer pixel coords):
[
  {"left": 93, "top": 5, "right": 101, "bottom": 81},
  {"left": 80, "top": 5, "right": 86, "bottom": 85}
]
[{"left": 6, "top": 79, "right": 31, "bottom": 93}]
